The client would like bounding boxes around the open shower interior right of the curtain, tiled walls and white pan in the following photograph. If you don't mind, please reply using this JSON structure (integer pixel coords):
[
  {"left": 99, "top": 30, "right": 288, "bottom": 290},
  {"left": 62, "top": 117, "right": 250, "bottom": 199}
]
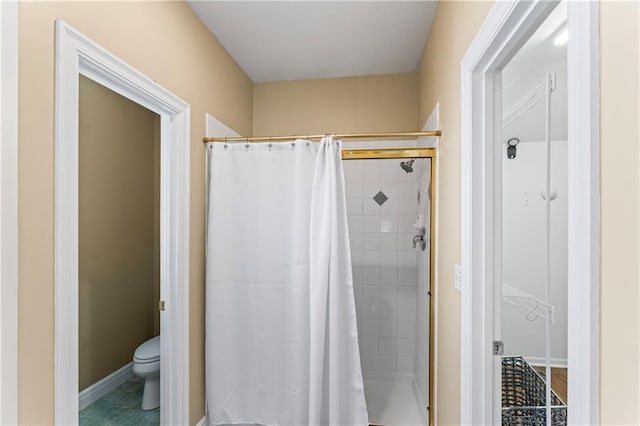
[{"left": 343, "top": 140, "right": 433, "bottom": 425}]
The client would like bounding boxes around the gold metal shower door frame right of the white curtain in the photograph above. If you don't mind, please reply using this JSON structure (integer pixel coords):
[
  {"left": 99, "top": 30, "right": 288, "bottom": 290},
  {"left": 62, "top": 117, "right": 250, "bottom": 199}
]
[{"left": 342, "top": 147, "right": 437, "bottom": 426}]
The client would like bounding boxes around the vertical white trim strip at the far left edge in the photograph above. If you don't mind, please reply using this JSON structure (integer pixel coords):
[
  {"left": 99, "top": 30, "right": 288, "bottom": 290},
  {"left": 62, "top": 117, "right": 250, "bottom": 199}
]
[{"left": 0, "top": 1, "right": 18, "bottom": 424}]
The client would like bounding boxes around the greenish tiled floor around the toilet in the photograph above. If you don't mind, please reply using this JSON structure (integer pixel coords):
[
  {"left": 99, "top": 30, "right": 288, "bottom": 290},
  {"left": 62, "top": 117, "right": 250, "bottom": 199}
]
[{"left": 80, "top": 378, "right": 160, "bottom": 426}]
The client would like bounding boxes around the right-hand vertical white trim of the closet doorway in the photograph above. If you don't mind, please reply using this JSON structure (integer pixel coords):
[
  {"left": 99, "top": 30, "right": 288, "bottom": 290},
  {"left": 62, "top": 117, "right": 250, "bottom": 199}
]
[{"left": 567, "top": 1, "right": 600, "bottom": 425}]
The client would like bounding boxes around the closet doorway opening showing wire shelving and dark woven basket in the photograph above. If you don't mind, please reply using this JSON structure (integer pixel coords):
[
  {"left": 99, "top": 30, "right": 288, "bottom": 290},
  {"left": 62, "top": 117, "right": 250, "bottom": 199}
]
[{"left": 494, "top": 3, "right": 571, "bottom": 425}]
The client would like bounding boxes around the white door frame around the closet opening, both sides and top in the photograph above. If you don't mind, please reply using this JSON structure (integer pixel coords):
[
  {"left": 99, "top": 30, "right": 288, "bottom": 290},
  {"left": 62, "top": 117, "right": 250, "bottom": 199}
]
[{"left": 460, "top": 0, "right": 600, "bottom": 424}]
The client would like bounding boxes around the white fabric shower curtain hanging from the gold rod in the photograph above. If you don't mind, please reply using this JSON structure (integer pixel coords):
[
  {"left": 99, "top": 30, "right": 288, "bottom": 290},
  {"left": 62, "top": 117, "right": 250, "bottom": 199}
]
[{"left": 205, "top": 138, "right": 368, "bottom": 426}]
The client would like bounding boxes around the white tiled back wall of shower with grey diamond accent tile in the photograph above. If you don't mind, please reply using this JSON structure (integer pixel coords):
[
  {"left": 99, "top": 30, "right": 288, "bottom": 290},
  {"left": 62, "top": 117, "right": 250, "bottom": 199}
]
[{"left": 343, "top": 148, "right": 421, "bottom": 374}]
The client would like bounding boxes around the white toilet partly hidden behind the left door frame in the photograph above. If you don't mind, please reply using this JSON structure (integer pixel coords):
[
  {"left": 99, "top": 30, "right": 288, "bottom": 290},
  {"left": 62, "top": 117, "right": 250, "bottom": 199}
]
[{"left": 133, "top": 336, "right": 160, "bottom": 410}]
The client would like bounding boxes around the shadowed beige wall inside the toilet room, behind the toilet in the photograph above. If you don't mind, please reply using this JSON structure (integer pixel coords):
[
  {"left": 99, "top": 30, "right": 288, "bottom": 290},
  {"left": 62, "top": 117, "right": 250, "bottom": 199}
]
[{"left": 78, "top": 77, "right": 160, "bottom": 390}]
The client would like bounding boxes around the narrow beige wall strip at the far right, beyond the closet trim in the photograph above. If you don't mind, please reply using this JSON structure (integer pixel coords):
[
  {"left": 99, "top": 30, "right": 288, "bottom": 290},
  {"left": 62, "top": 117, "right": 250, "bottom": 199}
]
[{"left": 600, "top": 2, "right": 640, "bottom": 425}]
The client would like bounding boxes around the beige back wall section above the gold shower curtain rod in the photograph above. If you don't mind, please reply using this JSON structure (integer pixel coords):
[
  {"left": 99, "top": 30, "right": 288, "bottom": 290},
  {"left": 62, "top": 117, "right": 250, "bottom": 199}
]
[{"left": 253, "top": 73, "right": 418, "bottom": 135}]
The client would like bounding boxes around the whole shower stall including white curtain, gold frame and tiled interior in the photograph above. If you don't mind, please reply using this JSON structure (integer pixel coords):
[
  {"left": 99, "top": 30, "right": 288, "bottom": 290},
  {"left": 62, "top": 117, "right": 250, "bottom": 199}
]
[{"left": 205, "top": 131, "right": 439, "bottom": 425}]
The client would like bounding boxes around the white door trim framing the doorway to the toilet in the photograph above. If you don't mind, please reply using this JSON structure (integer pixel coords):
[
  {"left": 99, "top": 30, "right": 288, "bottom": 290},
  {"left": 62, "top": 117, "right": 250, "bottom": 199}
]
[{"left": 54, "top": 20, "right": 191, "bottom": 425}]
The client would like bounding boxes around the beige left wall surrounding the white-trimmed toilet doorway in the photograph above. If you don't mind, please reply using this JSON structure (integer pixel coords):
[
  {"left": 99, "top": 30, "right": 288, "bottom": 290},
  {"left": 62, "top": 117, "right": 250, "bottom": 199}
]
[{"left": 18, "top": 2, "right": 252, "bottom": 425}]
